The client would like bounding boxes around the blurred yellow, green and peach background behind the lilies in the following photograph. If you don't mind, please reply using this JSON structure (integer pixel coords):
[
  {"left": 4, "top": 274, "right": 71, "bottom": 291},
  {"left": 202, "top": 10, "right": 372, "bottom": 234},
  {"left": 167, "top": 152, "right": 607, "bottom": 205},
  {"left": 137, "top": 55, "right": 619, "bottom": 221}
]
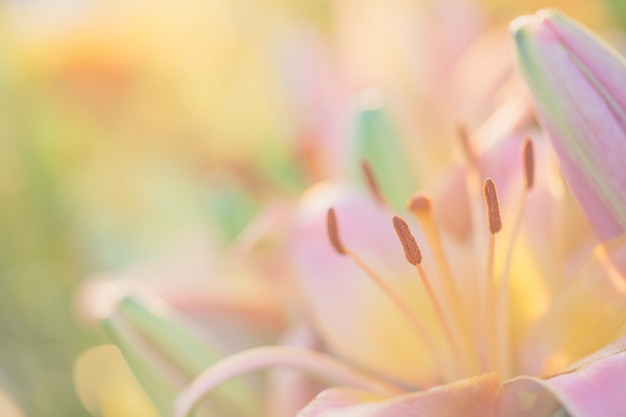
[{"left": 0, "top": 0, "right": 626, "bottom": 417}]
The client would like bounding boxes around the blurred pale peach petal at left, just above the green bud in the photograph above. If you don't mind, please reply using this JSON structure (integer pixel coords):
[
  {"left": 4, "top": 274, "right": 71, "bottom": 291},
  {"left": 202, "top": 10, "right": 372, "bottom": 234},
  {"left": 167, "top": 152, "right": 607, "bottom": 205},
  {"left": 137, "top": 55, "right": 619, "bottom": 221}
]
[{"left": 76, "top": 232, "right": 284, "bottom": 334}]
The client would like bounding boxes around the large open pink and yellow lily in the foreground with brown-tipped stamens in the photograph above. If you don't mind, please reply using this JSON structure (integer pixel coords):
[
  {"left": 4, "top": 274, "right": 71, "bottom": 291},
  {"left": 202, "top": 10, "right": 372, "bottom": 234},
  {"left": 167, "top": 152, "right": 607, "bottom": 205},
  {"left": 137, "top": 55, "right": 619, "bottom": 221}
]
[{"left": 175, "top": 124, "right": 626, "bottom": 417}]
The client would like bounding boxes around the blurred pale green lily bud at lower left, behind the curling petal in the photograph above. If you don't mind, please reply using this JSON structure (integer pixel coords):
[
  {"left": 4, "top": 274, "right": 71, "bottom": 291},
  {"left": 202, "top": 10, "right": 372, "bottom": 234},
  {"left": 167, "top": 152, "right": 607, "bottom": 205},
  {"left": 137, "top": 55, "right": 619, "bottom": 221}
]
[{"left": 104, "top": 296, "right": 260, "bottom": 416}]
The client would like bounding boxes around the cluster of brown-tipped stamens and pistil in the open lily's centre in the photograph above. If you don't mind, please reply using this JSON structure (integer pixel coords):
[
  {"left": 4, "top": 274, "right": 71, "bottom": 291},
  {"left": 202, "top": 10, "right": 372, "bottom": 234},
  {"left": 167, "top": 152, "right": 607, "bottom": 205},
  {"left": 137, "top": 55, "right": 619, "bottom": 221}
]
[{"left": 327, "top": 135, "right": 534, "bottom": 379}]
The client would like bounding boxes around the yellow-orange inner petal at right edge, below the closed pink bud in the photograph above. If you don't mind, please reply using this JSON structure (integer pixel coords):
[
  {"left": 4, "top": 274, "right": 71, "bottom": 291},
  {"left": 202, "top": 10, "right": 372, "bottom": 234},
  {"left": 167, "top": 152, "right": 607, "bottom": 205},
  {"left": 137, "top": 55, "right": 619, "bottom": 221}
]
[{"left": 521, "top": 236, "right": 626, "bottom": 375}]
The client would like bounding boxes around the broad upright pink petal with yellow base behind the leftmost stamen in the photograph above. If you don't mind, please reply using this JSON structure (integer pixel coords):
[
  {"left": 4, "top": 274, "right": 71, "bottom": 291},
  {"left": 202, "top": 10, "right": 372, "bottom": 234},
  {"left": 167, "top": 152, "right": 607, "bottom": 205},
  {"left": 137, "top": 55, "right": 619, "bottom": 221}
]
[{"left": 292, "top": 184, "right": 443, "bottom": 384}]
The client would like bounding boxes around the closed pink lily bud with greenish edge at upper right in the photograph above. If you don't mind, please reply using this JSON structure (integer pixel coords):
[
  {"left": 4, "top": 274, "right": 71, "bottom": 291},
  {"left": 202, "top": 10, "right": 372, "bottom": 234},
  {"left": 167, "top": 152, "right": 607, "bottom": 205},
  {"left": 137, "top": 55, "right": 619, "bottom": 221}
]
[{"left": 511, "top": 10, "right": 626, "bottom": 238}]
